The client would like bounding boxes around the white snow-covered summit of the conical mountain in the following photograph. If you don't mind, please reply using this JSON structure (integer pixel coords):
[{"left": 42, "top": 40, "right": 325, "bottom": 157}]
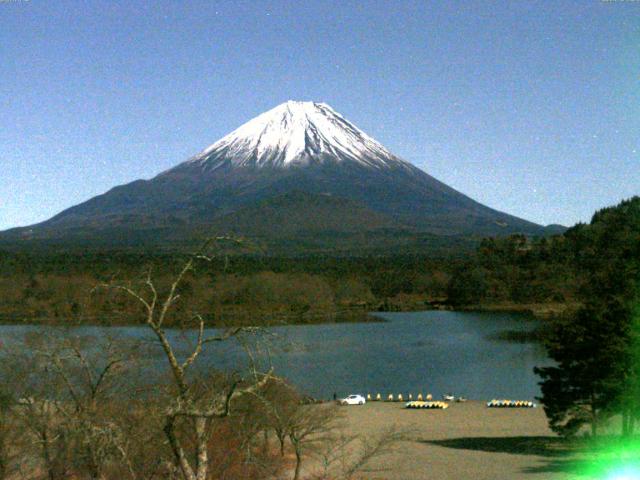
[{"left": 190, "top": 100, "right": 408, "bottom": 170}]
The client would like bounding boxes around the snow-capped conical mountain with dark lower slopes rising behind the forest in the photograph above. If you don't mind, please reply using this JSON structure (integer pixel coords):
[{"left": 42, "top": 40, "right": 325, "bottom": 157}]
[{"left": 0, "top": 101, "right": 548, "bottom": 251}]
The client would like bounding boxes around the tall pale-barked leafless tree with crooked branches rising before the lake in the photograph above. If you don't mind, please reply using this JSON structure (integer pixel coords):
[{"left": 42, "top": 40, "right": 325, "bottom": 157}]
[{"left": 97, "top": 237, "right": 272, "bottom": 480}]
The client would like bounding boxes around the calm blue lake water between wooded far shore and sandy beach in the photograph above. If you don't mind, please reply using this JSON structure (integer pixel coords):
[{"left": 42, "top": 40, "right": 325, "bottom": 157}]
[{"left": 0, "top": 311, "right": 550, "bottom": 400}]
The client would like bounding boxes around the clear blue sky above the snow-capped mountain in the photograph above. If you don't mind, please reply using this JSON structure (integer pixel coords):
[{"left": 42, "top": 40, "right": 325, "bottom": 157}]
[{"left": 0, "top": 0, "right": 640, "bottom": 229}]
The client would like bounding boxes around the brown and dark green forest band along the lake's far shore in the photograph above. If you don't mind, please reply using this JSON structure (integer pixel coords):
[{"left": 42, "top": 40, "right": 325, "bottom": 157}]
[{"left": 0, "top": 235, "right": 592, "bottom": 325}]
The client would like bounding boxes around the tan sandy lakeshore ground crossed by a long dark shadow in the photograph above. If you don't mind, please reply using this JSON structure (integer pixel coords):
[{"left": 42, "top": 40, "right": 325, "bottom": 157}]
[{"left": 341, "top": 401, "right": 575, "bottom": 480}]
